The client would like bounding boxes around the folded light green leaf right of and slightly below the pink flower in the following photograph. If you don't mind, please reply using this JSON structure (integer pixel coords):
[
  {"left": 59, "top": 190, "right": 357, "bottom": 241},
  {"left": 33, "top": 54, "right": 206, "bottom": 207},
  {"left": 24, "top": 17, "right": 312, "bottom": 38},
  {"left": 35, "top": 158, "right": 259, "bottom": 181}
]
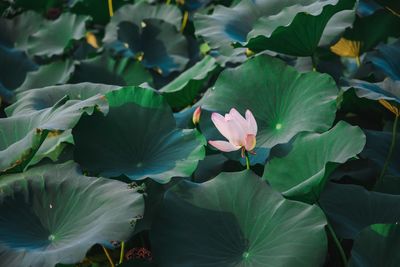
[{"left": 263, "top": 121, "right": 365, "bottom": 203}]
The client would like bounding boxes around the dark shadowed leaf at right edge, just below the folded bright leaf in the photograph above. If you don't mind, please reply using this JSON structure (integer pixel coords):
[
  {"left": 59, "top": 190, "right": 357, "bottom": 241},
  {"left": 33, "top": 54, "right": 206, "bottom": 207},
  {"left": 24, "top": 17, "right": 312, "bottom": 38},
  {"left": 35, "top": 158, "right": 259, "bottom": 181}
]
[{"left": 319, "top": 183, "right": 400, "bottom": 239}]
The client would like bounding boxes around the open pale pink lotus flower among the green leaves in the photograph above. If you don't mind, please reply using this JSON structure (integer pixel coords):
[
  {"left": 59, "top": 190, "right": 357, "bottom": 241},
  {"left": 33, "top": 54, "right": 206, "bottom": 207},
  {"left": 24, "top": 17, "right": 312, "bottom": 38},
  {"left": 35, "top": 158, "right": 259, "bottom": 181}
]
[{"left": 208, "top": 108, "right": 257, "bottom": 157}]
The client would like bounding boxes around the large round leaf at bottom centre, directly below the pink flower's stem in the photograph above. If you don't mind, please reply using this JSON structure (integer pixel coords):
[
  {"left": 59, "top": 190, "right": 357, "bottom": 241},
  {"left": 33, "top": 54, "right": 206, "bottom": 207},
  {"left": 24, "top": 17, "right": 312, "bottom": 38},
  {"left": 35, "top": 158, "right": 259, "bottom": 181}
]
[{"left": 151, "top": 171, "right": 326, "bottom": 267}]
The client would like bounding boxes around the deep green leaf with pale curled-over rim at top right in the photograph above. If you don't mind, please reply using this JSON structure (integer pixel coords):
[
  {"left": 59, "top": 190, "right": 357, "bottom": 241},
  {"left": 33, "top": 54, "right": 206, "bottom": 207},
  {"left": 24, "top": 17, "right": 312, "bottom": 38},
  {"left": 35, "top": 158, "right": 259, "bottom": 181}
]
[{"left": 246, "top": 0, "right": 355, "bottom": 56}]
